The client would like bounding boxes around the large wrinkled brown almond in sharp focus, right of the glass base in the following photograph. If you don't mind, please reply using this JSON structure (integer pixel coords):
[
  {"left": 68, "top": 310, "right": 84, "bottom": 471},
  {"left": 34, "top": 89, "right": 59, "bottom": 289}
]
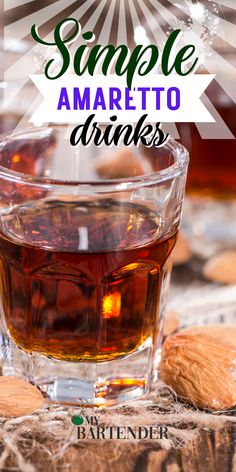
[{"left": 160, "top": 334, "right": 236, "bottom": 410}]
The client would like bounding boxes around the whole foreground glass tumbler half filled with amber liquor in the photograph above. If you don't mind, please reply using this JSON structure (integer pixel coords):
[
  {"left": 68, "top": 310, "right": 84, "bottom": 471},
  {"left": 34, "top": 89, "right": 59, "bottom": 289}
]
[{"left": 0, "top": 127, "right": 188, "bottom": 405}]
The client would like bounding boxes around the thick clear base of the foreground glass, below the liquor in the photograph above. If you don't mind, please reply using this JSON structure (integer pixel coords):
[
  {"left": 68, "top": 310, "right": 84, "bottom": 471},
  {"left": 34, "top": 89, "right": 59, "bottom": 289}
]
[{"left": 2, "top": 337, "right": 160, "bottom": 407}]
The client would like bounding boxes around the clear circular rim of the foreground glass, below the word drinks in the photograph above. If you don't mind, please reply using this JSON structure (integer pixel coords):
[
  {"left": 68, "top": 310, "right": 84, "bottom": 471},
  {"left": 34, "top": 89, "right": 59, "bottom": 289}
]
[{"left": 0, "top": 125, "right": 189, "bottom": 191}]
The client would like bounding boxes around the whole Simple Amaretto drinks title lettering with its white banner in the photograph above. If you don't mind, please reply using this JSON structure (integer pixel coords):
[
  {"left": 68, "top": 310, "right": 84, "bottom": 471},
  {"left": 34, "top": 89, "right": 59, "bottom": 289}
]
[{"left": 30, "top": 17, "right": 215, "bottom": 147}]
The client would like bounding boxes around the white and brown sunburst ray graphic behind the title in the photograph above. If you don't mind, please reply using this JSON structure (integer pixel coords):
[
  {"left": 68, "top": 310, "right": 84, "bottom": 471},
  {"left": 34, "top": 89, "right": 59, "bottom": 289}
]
[{"left": 4, "top": 0, "right": 236, "bottom": 139}]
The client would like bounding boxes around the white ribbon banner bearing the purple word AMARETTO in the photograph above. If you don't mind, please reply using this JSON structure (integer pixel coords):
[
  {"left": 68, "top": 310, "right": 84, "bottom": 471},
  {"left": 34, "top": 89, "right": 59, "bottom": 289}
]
[{"left": 30, "top": 74, "right": 215, "bottom": 123}]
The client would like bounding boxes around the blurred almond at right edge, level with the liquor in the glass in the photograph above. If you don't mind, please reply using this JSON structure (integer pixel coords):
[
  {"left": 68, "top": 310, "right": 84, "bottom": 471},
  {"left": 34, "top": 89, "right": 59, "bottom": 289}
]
[{"left": 203, "top": 250, "right": 236, "bottom": 284}]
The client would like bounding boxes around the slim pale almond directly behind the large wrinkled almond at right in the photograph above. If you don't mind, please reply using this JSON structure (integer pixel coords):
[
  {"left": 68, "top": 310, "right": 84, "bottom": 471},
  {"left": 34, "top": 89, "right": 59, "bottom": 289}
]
[{"left": 180, "top": 323, "right": 236, "bottom": 349}]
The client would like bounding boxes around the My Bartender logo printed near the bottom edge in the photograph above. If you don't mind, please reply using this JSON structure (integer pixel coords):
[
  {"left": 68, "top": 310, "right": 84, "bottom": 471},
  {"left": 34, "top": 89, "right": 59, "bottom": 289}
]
[{"left": 71, "top": 415, "right": 168, "bottom": 440}]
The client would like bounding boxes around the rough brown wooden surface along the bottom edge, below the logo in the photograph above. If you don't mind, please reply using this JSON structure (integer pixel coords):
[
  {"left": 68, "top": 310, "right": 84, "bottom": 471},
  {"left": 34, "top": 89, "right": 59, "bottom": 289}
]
[{"left": 0, "top": 426, "right": 236, "bottom": 472}]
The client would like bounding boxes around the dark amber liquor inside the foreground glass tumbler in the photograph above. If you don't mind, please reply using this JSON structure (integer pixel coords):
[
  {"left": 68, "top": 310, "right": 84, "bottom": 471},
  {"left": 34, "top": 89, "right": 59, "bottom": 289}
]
[{"left": 0, "top": 200, "right": 176, "bottom": 361}]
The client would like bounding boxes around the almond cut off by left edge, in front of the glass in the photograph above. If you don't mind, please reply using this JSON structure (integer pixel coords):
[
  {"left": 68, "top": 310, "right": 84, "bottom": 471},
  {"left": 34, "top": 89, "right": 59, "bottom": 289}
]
[{"left": 0, "top": 377, "right": 44, "bottom": 417}]
